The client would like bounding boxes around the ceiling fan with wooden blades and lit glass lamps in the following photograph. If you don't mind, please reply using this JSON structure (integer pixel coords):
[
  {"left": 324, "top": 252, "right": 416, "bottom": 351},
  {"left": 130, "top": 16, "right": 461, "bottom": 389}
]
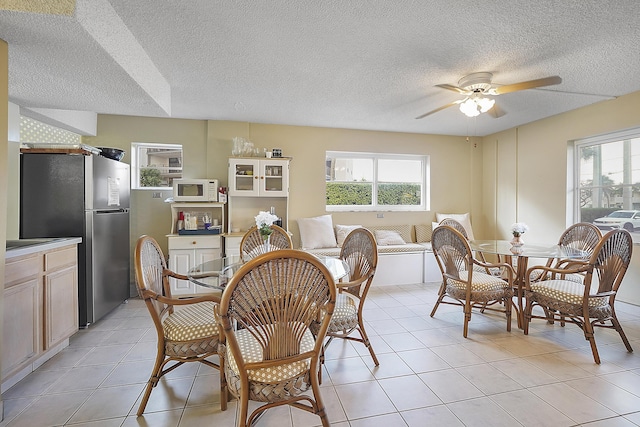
[{"left": 416, "top": 72, "right": 562, "bottom": 119}]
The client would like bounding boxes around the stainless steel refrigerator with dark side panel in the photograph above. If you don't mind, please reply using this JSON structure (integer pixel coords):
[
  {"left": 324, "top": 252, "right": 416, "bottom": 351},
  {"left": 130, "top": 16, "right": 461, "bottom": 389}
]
[{"left": 20, "top": 153, "right": 130, "bottom": 327}]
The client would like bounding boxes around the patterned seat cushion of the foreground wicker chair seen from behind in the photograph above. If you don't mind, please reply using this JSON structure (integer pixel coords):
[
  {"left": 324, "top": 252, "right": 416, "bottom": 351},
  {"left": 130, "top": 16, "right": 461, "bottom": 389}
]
[{"left": 226, "top": 329, "right": 315, "bottom": 384}]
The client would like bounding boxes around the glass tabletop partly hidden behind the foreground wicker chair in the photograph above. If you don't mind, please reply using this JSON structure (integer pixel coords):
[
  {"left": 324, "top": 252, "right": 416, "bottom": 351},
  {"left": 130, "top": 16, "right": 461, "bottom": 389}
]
[{"left": 187, "top": 255, "right": 349, "bottom": 291}]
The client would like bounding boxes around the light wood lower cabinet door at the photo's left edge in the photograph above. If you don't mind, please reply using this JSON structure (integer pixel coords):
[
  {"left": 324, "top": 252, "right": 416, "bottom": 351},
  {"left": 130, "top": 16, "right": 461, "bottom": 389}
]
[{"left": 2, "top": 278, "right": 40, "bottom": 379}]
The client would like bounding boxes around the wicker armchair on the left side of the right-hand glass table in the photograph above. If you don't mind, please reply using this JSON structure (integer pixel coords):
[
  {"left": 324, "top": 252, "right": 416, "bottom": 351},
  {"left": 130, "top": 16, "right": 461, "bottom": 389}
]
[{"left": 431, "top": 225, "right": 515, "bottom": 338}]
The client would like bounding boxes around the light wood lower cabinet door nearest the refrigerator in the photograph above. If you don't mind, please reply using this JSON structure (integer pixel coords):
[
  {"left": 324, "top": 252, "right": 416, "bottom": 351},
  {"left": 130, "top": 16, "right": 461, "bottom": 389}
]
[{"left": 44, "top": 266, "right": 78, "bottom": 350}]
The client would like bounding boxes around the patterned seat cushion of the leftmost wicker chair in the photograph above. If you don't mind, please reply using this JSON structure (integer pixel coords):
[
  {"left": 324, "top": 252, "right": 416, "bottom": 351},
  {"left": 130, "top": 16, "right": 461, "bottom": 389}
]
[{"left": 162, "top": 301, "right": 218, "bottom": 341}]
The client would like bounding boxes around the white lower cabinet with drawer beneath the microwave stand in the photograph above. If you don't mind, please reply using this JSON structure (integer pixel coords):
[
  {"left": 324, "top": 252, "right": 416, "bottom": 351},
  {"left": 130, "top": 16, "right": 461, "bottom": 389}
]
[{"left": 168, "top": 235, "right": 222, "bottom": 297}]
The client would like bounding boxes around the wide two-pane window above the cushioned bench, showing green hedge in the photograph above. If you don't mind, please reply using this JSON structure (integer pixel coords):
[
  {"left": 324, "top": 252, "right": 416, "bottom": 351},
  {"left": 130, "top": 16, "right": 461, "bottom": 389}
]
[{"left": 325, "top": 151, "right": 428, "bottom": 211}]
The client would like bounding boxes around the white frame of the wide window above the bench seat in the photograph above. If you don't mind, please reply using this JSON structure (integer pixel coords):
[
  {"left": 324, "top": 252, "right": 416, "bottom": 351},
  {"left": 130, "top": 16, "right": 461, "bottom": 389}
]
[{"left": 324, "top": 150, "right": 431, "bottom": 212}]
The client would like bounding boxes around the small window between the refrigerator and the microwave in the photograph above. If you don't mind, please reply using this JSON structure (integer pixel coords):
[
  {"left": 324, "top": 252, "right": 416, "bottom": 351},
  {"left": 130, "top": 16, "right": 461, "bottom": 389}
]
[{"left": 131, "top": 142, "right": 182, "bottom": 190}]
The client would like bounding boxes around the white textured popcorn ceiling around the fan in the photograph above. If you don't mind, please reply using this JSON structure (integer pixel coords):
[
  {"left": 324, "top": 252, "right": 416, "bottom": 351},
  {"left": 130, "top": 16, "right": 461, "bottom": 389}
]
[{"left": 0, "top": 0, "right": 640, "bottom": 136}]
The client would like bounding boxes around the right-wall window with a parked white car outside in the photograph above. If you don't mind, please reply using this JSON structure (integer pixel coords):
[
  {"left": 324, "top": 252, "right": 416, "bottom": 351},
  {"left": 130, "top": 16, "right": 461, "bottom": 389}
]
[{"left": 574, "top": 129, "right": 640, "bottom": 240}]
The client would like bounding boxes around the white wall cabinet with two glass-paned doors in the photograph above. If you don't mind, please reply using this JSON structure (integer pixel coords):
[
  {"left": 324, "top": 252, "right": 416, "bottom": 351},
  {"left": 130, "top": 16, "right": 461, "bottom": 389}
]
[{"left": 229, "top": 158, "right": 290, "bottom": 197}]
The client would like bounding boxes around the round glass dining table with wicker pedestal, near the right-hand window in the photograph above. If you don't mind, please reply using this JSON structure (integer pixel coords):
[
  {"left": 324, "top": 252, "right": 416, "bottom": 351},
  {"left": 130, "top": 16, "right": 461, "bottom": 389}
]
[{"left": 469, "top": 240, "right": 588, "bottom": 329}]
